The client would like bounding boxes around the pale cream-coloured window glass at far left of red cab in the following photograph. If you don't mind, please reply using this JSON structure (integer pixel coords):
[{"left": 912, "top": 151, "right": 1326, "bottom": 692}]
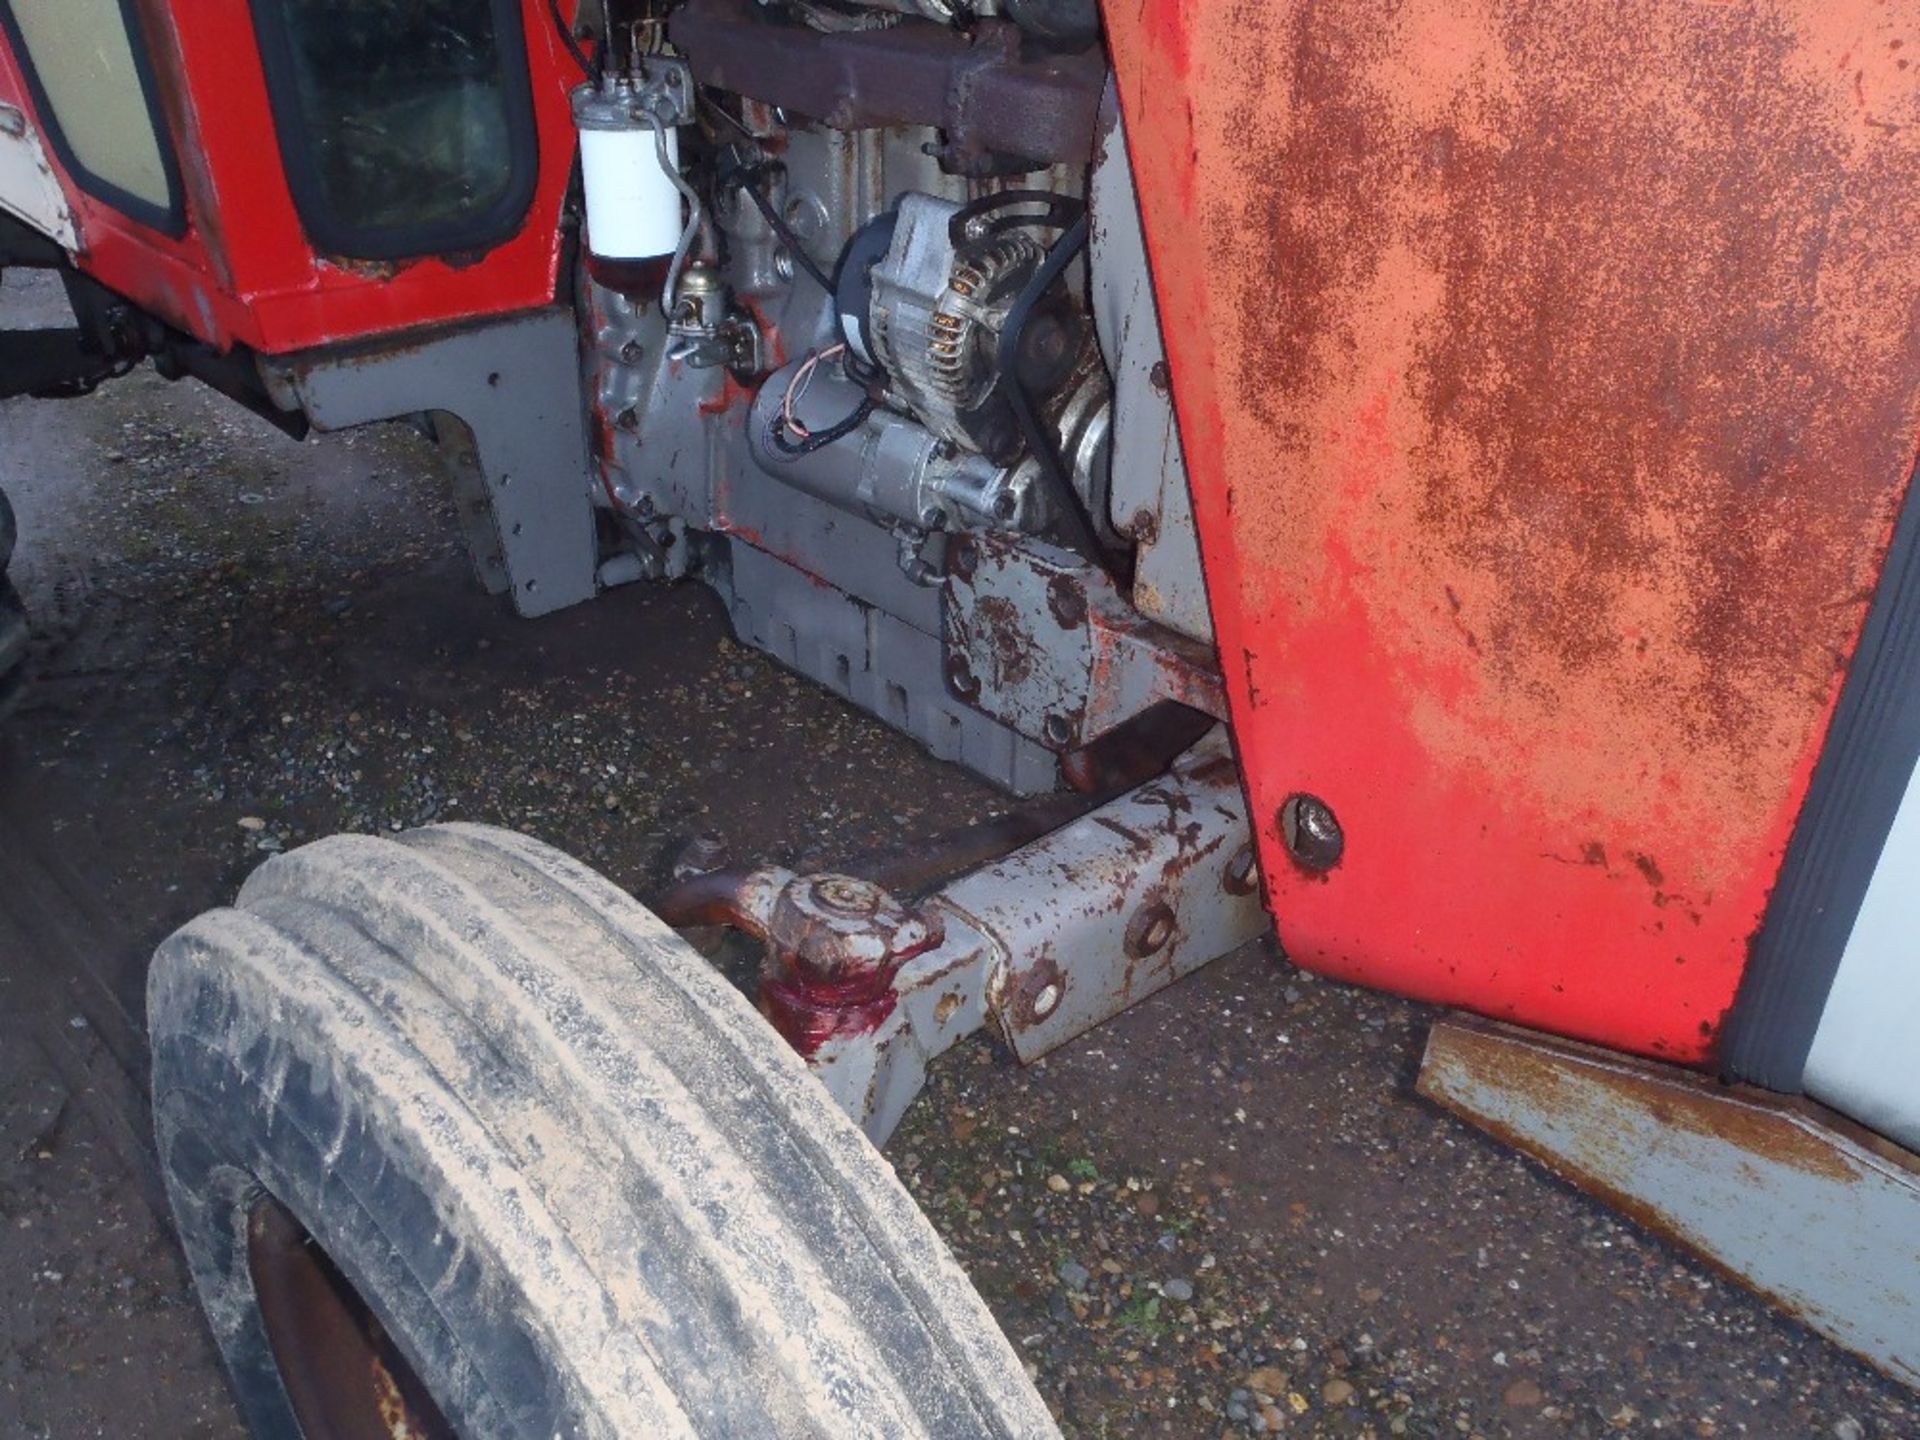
[{"left": 10, "top": 0, "right": 175, "bottom": 219}]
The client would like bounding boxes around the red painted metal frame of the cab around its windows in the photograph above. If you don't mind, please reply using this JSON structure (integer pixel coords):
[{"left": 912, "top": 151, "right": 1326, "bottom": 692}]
[{"left": 0, "top": 0, "right": 578, "bottom": 353}]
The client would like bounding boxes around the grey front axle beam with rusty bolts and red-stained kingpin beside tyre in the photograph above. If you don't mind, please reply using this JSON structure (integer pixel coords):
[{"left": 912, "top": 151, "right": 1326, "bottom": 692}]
[{"left": 662, "top": 730, "right": 1267, "bottom": 1144}]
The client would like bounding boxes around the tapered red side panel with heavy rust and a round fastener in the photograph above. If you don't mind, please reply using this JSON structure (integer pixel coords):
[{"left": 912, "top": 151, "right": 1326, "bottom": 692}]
[{"left": 1108, "top": 0, "right": 1920, "bottom": 1060}]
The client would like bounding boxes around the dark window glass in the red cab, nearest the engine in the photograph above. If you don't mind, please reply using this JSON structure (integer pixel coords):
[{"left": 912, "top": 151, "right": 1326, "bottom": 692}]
[{"left": 255, "top": 0, "right": 526, "bottom": 255}]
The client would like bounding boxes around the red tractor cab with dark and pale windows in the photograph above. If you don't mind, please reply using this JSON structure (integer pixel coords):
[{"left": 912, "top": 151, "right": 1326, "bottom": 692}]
[{"left": 0, "top": 0, "right": 578, "bottom": 407}]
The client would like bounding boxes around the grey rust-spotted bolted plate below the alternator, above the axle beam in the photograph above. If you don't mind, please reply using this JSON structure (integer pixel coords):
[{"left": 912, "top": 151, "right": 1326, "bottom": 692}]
[{"left": 943, "top": 536, "right": 1227, "bottom": 751}]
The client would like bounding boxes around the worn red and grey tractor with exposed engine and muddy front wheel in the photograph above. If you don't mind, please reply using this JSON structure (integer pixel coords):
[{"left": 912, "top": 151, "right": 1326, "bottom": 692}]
[{"left": 0, "top": 0, "right": 1920, "bottom": 1436}]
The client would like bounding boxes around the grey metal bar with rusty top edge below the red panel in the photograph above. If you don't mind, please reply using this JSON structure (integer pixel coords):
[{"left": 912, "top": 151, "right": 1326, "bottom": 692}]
[{"left": 1419, "top": 1020, "right": 1920, "bottom": 1384}]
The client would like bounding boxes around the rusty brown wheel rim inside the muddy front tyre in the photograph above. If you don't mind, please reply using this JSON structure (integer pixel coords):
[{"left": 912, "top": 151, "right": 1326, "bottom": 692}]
[{"left": 246, "top": 1196, "right": 457, "bottom": 1440}]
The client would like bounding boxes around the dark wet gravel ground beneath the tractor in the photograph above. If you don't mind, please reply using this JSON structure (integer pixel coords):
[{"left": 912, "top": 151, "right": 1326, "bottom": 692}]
[{"left": 0, "top": 272, "right": 1920, "bottom": 1440}]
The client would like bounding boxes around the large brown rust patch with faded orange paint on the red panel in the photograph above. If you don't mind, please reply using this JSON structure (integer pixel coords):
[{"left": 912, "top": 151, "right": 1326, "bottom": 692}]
[{"left": 1210, "top": 0, "right": 1920, "bottom": 864}]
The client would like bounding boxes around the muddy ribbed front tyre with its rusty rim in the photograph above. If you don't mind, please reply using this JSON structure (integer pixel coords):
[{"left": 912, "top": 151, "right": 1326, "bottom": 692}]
[{"left": 148, "top": 826, "right": 1054, "bottom": 1440}]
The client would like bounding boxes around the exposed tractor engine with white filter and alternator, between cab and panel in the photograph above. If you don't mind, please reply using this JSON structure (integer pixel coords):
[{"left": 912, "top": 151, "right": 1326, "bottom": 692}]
[{"left": 574, "top": 0, "right": 1225, "bottom": 793}]
